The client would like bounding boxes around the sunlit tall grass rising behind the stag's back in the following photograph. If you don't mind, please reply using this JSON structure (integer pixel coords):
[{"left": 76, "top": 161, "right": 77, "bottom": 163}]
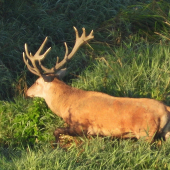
[{"left": 72, "top": 40, "right": 170, "bottom": 101}]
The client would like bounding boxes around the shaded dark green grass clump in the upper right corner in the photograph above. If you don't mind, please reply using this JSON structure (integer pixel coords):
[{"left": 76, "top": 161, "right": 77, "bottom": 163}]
[{"left": 100, "top": 0, "right": 170, "bottom": 44}]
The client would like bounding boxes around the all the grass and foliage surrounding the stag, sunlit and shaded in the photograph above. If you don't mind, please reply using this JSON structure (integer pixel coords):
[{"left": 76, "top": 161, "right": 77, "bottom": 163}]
[{"left": 0, "top": 0, "right": 170, "bottom": 170}]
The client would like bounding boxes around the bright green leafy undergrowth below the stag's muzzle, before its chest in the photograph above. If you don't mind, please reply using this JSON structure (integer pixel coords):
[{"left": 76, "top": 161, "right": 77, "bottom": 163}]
[{"left": 0, "top": 98, "right": 62, "bottom": 147}]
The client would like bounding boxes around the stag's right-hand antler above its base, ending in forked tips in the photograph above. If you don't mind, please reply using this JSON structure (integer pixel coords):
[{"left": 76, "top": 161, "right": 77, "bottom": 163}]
[{"left": 54, "top": 27, "right": 94, "bottom": 71}]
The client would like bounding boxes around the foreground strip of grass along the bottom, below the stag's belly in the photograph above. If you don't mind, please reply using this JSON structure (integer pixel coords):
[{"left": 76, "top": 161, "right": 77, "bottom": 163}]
[{"left": 0, "top": 138, "right": 170, "bottom": 170}]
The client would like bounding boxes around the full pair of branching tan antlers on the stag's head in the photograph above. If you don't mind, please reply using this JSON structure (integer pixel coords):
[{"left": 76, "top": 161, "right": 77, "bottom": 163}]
[{"left": 23, "top": 27, "right": 94, "bottom": 76}]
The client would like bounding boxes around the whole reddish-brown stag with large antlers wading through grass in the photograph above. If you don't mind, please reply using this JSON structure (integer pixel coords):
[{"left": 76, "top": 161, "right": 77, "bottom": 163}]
[{"left": 23, "top": 27, "right": 170, "bottom": 142}]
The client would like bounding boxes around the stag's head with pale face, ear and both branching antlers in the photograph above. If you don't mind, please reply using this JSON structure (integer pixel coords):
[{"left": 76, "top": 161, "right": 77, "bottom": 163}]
[{"left": 23, "top": 27, "right": 94, "bottom": 97}]
